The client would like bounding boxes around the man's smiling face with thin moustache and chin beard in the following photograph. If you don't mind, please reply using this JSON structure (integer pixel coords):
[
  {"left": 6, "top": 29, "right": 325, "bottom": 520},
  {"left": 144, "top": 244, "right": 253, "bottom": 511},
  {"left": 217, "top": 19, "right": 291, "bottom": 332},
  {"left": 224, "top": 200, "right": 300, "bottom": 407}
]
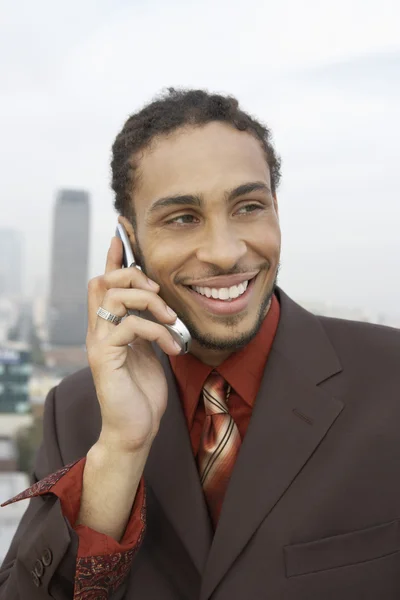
[{"left": 130, "top": 122, "right": 281, "bottom": 350}]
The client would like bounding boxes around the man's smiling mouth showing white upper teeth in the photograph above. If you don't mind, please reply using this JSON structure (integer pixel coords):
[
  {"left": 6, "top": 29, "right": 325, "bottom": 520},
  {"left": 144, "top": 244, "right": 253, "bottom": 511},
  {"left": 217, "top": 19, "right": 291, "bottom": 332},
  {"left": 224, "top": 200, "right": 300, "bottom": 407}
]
[{"left": 185, "top": 274, "right": 258, "bottom": 315}]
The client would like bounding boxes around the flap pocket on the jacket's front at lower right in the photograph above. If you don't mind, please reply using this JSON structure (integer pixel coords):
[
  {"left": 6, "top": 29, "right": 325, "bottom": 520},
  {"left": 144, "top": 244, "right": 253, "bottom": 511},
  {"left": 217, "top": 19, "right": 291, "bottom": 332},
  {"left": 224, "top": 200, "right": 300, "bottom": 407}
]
[{"left": 284, "top": 520, "right": 400, "bottom": 577}]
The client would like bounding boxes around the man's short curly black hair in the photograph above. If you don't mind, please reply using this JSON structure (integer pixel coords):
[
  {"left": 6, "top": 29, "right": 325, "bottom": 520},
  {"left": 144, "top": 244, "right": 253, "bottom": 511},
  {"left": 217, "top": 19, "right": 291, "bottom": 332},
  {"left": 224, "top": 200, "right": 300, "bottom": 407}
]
[{"left": 111, "top": 88, "right": 281, "bottom": 225}]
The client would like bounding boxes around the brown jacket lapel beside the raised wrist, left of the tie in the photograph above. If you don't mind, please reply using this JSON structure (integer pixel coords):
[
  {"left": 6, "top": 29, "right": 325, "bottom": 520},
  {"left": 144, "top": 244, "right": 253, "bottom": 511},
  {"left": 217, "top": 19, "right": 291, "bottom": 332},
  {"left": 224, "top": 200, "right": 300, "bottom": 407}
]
[{"left": 144, "top": 349, "right": 212, "bottom": 574}]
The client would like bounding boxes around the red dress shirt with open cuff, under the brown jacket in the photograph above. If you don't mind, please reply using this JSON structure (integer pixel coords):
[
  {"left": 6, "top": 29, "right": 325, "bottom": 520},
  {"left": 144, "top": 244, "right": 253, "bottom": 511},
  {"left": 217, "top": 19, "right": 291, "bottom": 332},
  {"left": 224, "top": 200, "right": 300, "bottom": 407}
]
[{"left": 2, "top": 296, "right": 280, "bottom": 562}]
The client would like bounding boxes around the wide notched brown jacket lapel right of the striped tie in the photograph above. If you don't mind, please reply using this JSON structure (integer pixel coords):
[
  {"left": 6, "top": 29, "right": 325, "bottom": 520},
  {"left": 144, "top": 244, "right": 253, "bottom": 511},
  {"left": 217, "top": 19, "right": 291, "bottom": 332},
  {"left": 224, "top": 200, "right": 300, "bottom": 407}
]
[{"left": 200, "top": 290, "right": 343, "bottom": 600}]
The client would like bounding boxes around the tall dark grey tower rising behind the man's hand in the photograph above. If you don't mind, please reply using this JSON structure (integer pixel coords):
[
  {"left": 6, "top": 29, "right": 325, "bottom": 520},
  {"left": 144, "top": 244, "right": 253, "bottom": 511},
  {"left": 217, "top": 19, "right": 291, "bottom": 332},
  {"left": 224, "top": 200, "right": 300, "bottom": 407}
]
[{"left": 49, "top": 190, "right": 90, "bottom": 346}]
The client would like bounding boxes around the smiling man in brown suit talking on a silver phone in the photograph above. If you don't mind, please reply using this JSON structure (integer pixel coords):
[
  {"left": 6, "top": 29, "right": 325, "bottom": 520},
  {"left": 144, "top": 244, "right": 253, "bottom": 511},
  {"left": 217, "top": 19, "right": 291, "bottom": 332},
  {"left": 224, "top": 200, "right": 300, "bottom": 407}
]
[{"left": 0, "top": 90, "right": 400, "bottom": 600}]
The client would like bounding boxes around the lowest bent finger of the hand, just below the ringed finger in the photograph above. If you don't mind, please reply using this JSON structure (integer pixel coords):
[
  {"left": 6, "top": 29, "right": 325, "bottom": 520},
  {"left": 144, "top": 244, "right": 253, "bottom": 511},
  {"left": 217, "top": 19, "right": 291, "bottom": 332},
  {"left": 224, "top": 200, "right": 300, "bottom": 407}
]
[{"left": 107, "top": 315, "right": 181, "bottom": 355}]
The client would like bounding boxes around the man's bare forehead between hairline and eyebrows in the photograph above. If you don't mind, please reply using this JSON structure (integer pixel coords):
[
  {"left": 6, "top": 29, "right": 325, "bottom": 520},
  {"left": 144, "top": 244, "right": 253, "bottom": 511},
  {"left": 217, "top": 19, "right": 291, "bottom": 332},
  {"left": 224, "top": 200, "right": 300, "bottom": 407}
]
[{"left": 135, "top": 122, "right": 270, "bottom": 206}]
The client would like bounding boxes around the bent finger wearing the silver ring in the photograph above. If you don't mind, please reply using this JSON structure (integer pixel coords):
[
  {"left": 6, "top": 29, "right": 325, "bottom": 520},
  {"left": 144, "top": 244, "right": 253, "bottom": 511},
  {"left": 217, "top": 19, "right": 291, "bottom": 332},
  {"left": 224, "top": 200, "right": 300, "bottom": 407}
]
[{"left": 95, "top": 288, "right": 177, "bottom": 337}]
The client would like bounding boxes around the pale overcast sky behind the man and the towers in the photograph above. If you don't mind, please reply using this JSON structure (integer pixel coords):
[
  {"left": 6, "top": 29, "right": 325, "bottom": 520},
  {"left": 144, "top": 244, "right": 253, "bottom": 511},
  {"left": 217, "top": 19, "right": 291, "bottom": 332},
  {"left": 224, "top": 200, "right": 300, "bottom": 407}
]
[{"left": 0, "top": 0, "right": 400, "bottom": 324}]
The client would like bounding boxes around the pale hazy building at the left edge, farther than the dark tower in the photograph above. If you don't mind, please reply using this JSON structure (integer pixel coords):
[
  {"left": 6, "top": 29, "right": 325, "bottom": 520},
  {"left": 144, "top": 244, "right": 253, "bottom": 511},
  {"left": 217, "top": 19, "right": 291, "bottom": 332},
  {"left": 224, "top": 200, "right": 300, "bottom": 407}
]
[{"left": 0, "top": 229, "right": 23, "bottom": 296}]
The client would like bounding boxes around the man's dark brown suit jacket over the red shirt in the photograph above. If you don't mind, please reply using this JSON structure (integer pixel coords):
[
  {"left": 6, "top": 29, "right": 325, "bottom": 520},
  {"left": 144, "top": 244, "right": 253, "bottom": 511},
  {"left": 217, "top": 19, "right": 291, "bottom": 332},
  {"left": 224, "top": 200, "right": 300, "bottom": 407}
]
[{"left": 0, "top": 289, "right": 400, "bottom": 600}]
